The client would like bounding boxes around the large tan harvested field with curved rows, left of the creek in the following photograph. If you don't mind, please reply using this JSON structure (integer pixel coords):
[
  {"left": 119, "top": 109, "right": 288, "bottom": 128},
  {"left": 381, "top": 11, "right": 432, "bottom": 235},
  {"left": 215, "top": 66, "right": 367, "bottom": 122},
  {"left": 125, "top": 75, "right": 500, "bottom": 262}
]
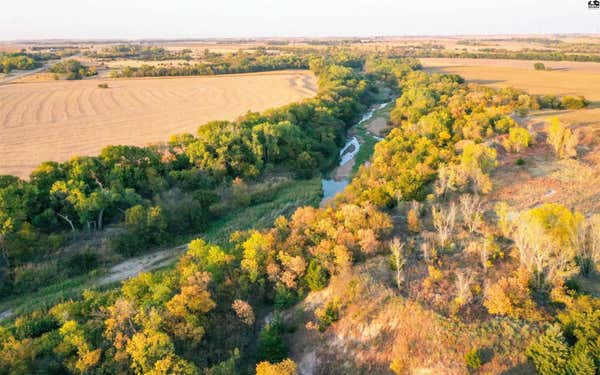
[{"left": 0, "top": 71, "right": 316, "bottom": 178}]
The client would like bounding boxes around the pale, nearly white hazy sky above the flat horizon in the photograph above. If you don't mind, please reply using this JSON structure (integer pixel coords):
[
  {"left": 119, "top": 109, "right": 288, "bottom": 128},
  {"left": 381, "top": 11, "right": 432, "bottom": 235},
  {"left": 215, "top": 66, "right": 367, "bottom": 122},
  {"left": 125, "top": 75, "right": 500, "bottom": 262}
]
[{"left": 0, "top": 0, "right": 600, "bottom": 40}]
